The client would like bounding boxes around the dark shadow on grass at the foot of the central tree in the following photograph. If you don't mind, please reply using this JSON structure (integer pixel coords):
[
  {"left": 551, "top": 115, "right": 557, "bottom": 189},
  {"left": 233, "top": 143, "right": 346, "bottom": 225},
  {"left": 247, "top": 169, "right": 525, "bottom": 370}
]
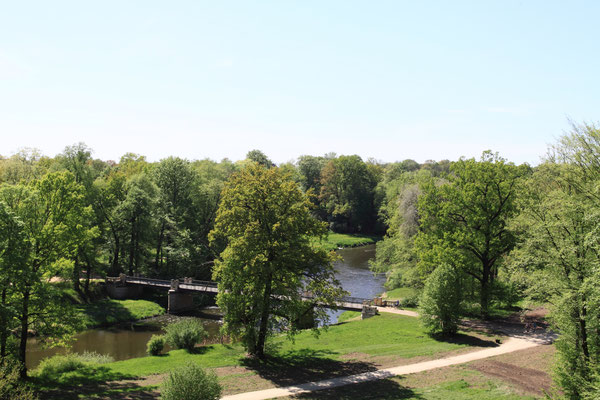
[{"left": 242, "top": 349, "right": 377, "bottom": 386}]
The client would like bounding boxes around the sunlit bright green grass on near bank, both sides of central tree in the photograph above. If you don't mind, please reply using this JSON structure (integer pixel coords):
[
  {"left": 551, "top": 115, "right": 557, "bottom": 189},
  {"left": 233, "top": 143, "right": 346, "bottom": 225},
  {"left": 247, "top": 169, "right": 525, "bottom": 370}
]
[{"left": 104, "top": 314, "right": 474, "bottom": 376}]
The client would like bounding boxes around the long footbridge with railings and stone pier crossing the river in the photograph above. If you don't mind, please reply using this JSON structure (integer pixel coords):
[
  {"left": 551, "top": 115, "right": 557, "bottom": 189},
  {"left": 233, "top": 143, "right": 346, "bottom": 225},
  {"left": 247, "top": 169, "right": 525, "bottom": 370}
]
[{"left": 106, "top": 274, "right": 371, "bottom": 313}]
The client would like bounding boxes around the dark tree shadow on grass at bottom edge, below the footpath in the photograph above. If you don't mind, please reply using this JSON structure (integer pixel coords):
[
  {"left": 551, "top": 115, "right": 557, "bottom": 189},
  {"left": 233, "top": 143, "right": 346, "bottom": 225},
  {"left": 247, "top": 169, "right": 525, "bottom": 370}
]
[{"left": 292, "top": 378, "right": 422, "bottom": 400}]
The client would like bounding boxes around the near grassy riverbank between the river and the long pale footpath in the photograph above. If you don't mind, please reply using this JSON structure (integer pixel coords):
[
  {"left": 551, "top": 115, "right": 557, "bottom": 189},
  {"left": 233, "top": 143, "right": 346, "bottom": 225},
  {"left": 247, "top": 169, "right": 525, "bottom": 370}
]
[{"left": 34, "top": 314, "right": 502, "bottom": 398}]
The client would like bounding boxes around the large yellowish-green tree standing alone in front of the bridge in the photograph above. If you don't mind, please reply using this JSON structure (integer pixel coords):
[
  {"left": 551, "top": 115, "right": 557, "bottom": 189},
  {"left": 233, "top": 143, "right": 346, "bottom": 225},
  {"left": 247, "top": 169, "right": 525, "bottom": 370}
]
[{"left": 210, "top": 164, "right": 343, "bottom": 357}]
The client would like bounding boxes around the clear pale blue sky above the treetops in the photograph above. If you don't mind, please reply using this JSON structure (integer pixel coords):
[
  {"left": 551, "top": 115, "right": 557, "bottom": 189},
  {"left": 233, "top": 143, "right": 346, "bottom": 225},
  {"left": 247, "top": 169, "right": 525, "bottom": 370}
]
[{"left": 0, "top": 0, "right": 600, "bottom": 164}]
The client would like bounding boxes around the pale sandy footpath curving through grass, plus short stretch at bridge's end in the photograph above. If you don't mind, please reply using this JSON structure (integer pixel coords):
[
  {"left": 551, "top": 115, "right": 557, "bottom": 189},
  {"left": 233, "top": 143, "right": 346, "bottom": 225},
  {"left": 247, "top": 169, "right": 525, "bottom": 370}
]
[{"left": 222, "top": 307, "right": 553, "bottom": 400}]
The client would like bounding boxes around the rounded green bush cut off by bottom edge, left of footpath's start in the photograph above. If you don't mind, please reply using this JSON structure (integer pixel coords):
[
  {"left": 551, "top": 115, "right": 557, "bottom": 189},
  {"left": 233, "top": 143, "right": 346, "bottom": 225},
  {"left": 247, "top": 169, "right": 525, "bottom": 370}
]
[{"left": 160, "top": 363, "right": 223, "bottom": 400}]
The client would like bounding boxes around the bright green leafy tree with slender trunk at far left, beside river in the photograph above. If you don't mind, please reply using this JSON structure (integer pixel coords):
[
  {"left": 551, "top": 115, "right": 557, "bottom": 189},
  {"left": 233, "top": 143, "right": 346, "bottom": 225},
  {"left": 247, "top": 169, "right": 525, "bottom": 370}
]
[{"left": 0, "top": 172, "right": 91, "bottom": 377}]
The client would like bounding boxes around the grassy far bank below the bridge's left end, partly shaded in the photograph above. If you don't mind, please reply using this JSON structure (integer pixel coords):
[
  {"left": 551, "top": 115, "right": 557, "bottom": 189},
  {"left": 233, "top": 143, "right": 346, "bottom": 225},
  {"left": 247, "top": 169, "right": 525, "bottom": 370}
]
[{"left": 77, "top": 299, "right": 165, "bottom": 328}]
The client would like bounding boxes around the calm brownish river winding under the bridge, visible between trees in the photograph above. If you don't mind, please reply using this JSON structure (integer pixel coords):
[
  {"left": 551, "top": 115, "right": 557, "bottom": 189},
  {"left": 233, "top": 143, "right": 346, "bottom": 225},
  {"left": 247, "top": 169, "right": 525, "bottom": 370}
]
[{"left": 27, "top": 245, "right": 385, "bottom": 368}]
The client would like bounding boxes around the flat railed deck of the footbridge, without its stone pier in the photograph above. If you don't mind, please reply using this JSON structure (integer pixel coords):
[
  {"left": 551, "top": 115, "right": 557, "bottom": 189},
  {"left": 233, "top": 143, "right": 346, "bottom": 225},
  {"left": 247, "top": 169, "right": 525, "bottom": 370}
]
[{"left": 106, "top": 276, "right": 370, "bottom": 311}]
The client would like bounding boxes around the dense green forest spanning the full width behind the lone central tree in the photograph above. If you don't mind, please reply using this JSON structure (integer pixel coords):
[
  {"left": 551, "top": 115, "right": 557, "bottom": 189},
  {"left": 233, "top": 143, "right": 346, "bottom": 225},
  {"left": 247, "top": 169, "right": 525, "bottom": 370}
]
[{"left": 0, "top": 124, "right": 600, "bottom": 398}]
